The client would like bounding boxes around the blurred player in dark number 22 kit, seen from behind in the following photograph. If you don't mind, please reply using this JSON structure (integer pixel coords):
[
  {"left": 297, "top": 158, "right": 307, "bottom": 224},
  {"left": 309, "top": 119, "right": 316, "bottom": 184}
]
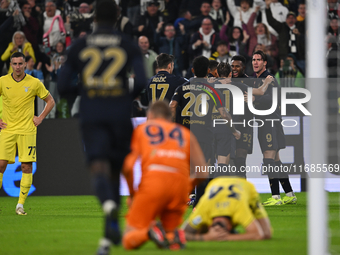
[{"left": 58, "top": 0, "right": 146, "bottom": 254}]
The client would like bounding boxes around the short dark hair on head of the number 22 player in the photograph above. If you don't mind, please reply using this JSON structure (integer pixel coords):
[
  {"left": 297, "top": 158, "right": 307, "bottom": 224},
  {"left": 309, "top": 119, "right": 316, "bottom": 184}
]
[{"left": 95, "top": 0, "right": 118, "bottom": 26}]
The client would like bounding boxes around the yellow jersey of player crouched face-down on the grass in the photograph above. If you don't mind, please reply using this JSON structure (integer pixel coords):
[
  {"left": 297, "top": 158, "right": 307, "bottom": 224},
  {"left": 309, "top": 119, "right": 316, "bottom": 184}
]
[{"left": 188, "top": 177, "right": 268, "bottom": 230}]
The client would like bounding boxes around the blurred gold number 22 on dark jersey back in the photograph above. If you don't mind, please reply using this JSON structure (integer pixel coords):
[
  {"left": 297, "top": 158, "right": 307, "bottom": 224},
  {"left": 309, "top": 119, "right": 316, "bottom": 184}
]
[{"left": 79, "top": 47, "right": 127, "bottom": 89}]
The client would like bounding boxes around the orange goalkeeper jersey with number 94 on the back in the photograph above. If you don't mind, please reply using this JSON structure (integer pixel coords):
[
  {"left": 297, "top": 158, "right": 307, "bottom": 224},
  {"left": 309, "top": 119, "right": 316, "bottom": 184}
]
[{"left": 124, "top": 119, "right": 195, "bottom": 194}]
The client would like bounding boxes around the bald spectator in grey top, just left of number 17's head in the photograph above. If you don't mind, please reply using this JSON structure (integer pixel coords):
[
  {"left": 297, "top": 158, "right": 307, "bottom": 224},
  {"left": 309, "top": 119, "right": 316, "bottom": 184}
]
[{"left": 138, "top": 36, "right": 157, "bottom": 79}]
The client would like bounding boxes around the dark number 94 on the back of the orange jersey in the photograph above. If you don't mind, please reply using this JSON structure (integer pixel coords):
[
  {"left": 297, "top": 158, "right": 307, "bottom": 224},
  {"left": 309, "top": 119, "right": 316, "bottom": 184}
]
[{"left": 146, "top": 125, "right": 184, "bottom": 147}]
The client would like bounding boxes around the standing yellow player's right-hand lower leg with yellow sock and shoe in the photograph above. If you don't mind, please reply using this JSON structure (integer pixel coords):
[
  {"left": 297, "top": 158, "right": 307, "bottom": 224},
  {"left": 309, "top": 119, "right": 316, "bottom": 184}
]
[{"left": 15, "top": 162, "right": 33, "bottom": 215}]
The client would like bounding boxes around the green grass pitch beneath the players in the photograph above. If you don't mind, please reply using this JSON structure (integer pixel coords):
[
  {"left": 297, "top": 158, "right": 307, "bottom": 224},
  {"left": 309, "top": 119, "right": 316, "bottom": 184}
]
[{"left": 0, "top": 193, "right": 340, "bottom": 255}]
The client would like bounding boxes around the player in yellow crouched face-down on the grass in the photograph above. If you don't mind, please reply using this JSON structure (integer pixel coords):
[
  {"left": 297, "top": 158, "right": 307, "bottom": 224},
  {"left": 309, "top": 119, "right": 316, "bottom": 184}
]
[{"left": 184, "top": 177, "right": 271, "bottom": 241}]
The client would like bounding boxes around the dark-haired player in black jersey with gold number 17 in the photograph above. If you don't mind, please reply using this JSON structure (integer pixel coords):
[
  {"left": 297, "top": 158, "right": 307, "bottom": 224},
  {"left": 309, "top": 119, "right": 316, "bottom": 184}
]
[{"left": 146, "top": 53, "right": 188, "bottom": 103}]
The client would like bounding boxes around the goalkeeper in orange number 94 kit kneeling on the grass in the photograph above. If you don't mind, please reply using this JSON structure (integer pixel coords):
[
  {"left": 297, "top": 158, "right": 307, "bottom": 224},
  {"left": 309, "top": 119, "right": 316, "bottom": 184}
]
[{"left": 123, "top": 101, "right": 207, "bottom": 250}]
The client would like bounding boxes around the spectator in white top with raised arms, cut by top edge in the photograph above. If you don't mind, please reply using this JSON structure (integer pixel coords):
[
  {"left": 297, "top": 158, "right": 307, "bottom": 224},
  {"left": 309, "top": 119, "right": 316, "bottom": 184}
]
[{"left": 227, "top": 0, "right": 254, "bottom": 27}]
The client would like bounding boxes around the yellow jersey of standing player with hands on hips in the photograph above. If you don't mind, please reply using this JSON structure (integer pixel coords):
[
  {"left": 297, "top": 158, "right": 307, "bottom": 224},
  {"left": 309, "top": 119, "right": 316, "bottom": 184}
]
[{"left": 0, "top": 74, "right": 49, "bottom": 134}]
